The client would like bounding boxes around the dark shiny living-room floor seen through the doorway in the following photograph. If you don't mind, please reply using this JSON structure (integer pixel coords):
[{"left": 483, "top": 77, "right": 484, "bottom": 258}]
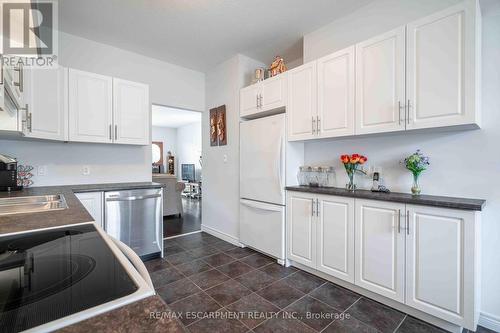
[{"left": 163, "top": 197, "right": 201, "bottom": 237}]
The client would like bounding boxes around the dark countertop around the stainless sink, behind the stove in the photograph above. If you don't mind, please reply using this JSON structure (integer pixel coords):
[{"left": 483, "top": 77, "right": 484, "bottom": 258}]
[{"left": 0, "top": 182, "right": 165, "bottom": 235}]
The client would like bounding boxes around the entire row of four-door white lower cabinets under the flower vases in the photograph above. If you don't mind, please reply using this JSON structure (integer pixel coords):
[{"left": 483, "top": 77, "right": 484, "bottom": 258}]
[{"left": 286, "top": 191, "right": 480, "bottom": 330}]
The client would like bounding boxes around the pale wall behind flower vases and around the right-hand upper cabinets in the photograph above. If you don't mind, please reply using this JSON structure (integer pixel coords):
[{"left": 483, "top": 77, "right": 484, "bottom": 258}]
[{"left": 304, "top": 0, "right": 500, "bottom": 323}]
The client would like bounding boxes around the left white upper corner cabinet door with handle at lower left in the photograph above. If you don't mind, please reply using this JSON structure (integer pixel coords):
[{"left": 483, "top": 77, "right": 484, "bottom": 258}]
[{"left": 25, "top": 66, "right": 68, "bottom": 141}]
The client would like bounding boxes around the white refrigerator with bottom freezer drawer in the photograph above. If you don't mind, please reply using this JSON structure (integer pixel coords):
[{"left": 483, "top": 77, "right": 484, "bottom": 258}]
[{"left": 240, "top": 114, "right": 286, "bottom": 261}]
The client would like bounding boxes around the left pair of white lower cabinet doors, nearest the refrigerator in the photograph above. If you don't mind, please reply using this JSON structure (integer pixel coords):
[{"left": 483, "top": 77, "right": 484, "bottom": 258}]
[{"left": 287, "top": 192, "right": 354, "bottom": 282}]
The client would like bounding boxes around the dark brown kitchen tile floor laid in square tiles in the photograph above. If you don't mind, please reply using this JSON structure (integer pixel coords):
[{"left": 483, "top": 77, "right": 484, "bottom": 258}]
[{"left": 146, "top": 233, "right": 491, "bottom": 333}]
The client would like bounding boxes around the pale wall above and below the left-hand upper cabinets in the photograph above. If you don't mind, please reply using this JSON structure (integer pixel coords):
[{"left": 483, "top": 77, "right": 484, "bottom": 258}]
[{"left": 0, "top": 33, "right": 205, "bottom": 186}]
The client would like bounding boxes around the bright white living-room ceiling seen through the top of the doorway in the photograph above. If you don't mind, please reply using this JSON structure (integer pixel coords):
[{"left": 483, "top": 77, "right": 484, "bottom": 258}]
[{"left": 151, "top": 105, "right": 201, "bottom": 128}]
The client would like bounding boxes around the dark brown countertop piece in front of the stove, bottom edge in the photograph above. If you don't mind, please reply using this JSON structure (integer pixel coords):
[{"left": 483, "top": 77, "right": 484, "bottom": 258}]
[{"left": 58, "top": 296, "right": 187, "bottom": 333}]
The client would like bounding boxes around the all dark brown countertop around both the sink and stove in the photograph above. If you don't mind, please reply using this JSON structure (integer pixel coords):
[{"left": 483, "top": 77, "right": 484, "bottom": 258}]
[{"left": 0, "top": 182, "right": 181, "bottom": 333}]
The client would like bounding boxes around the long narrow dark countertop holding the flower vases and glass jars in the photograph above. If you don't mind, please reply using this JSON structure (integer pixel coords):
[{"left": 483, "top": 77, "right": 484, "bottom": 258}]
[{"left": 286, "top": 186, "right": 486, "bottom": 211}]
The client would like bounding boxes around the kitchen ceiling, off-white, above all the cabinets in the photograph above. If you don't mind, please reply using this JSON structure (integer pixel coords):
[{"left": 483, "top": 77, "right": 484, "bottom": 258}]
[{"left": 59, "top": 0, "right": 373, "bottom": 71}]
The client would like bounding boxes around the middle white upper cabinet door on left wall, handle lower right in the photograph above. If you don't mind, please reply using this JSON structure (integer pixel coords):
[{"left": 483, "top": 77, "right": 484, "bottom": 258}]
[{"left": 69, "top": 68, "right": 113, "bottom": 143}]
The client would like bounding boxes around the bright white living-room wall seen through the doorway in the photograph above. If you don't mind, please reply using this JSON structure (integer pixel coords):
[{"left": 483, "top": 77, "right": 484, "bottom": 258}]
[{"left": 177, "top": 121, "right": 202, "bottom": 180}]
